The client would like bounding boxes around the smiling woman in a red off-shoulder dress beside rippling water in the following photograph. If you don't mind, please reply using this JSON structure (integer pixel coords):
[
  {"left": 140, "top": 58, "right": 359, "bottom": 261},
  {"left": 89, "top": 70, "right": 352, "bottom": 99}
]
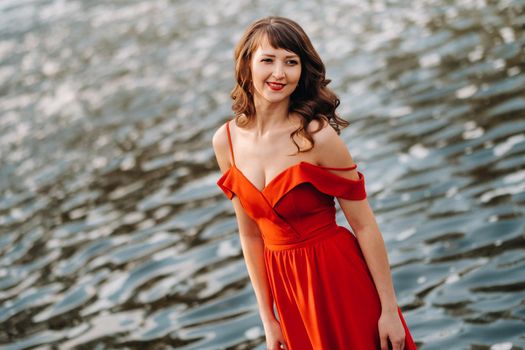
[{"left": 213, "top": 16, "right": 416, "bottom": 350}]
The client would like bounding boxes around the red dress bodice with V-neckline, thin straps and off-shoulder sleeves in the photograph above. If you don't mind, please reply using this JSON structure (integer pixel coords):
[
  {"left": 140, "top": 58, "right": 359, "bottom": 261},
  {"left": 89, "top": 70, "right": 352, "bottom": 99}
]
[{"left": 217, "top": 122, "right": 366, "bottom": 244}]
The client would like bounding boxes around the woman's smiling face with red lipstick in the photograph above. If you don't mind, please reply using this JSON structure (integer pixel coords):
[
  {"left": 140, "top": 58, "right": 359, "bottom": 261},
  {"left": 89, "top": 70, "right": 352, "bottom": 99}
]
[{"left": 251, "top": 36, "right": 301, "bottom": 103}]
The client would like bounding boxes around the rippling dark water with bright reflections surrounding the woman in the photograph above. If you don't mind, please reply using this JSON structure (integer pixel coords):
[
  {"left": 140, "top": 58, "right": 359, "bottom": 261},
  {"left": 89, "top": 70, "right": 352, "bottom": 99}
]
[{"left": 0, "top": 0, "right": 525, "bottom": 350}]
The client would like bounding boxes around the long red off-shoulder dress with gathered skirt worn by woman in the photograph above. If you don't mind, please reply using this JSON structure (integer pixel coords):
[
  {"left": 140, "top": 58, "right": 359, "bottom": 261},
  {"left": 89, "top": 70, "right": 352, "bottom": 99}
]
[{"left": 217, "top": 121, "right": 416, "bottom": 350}]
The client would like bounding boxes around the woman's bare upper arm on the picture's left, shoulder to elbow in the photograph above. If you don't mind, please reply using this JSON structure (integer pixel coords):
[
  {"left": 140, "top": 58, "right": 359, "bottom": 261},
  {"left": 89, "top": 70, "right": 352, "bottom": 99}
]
[{"left": 212, "top": 124, "right": 260, "bottom": 236}]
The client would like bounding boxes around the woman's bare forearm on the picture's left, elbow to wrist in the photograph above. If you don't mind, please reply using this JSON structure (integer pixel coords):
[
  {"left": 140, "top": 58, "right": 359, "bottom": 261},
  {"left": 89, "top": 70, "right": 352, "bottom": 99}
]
[{"left": 240, "top": 235, "right": 276, "bottom": 323}]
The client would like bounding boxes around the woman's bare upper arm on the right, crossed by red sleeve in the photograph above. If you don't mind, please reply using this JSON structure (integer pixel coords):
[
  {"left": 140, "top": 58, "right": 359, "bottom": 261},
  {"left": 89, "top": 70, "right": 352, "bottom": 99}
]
[{"left": 314, "top": 119, "right": 376, "bottom": 234}]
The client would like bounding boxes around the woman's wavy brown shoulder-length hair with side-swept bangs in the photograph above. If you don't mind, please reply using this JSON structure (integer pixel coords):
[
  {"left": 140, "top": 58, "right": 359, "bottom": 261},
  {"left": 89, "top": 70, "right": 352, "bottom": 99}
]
[{"left": 230, "top": 16, "right": 350, "bottom": 153}]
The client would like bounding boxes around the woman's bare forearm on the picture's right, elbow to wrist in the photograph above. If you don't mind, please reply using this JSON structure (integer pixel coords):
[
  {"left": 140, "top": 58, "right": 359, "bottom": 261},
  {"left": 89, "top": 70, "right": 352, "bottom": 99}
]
[{"left": 356, "top": 225, "right": 398, "bottom": 312}]
